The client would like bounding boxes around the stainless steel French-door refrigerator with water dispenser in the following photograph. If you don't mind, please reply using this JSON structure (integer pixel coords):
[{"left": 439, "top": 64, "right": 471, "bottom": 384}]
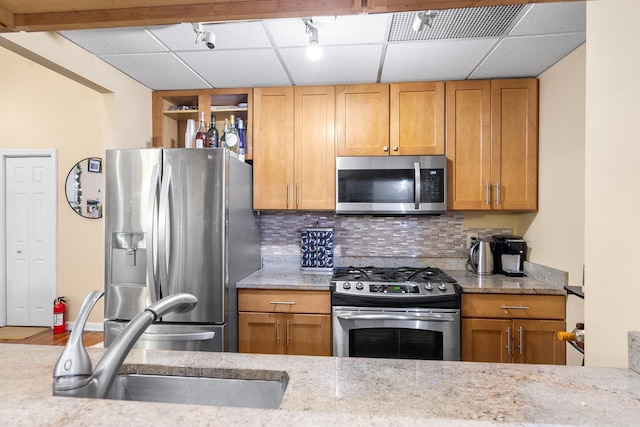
[{"left": 104, "top": 148, "right": 260, "bottom": 351}]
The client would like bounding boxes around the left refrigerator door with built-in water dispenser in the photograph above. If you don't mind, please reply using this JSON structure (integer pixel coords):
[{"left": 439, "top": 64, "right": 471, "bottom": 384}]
[{"left": 104, "top": 150, "right": 162, "bottom": 319}]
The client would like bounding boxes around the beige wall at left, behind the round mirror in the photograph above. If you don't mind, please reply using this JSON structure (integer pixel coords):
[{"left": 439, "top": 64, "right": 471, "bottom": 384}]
[{"left": 0, "top": 33, "right": 151, "bottom": 323}]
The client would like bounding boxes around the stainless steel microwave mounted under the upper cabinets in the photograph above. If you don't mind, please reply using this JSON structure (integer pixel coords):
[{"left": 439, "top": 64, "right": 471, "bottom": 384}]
[{"left": 336, "top": 155, "right": 447, "bottom": 215}]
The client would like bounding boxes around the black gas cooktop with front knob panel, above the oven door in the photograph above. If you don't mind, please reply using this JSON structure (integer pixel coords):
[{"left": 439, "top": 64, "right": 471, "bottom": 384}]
[{"left": 331, "top": 267, "right": 462, "bottom": 308}]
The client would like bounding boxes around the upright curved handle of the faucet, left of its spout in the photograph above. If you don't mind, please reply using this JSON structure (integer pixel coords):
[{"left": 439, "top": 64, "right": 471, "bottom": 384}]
[{"left": 53, "top": 290, "right": 104, "bottom": 378}]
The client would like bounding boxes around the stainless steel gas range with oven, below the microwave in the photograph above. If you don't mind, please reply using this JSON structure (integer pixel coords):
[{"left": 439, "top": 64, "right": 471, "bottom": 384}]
[{"left": 331, "top": 267, "right": 461, "bottom": 360}]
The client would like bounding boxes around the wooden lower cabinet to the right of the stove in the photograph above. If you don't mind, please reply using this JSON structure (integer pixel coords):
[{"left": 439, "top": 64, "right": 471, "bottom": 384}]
[{"left": 461, "top": 294, "right": 566, "bottom": 365}]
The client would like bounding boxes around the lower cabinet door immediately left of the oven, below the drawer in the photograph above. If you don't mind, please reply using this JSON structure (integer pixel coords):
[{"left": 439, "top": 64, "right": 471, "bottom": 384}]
[{"left": 285, "top": 314, "right": 332, "bottom": 356}]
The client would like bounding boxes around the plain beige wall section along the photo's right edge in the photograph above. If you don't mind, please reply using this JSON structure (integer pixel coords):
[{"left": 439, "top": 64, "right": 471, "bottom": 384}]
[{"left": 585, "top": 0, "right": 640, "bottom": 367}]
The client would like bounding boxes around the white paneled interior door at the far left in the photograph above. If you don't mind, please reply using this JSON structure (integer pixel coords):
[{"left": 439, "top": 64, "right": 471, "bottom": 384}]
[{"left": 5, "top": 157, "right": 56, "bottom": 326}]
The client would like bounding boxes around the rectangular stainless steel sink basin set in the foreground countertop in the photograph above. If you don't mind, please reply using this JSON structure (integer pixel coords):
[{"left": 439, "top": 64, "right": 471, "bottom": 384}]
[{"left": 107, "top": 370, "right": 289, "bottom": 409}]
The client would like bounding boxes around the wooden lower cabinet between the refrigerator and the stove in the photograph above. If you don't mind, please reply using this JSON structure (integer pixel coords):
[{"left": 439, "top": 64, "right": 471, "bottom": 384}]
[{"left": 238, "top": 289, "right": 332, "bottom": 356}]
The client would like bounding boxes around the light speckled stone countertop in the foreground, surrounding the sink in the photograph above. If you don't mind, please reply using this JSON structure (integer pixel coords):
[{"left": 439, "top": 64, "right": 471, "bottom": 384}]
[{"left": 0, "top": 344, "right": 640, "bottom": 427}]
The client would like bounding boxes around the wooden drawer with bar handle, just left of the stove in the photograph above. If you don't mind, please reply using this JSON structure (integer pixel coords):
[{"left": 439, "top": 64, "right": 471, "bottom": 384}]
[{"left": 238, "top": 289, "right": 331, "bottom": 314}]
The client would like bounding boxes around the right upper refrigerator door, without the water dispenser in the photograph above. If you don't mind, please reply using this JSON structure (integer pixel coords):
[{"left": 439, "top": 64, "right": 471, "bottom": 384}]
[{"left": 158, "top": 149, "right": 229, "bottom": 324}]
